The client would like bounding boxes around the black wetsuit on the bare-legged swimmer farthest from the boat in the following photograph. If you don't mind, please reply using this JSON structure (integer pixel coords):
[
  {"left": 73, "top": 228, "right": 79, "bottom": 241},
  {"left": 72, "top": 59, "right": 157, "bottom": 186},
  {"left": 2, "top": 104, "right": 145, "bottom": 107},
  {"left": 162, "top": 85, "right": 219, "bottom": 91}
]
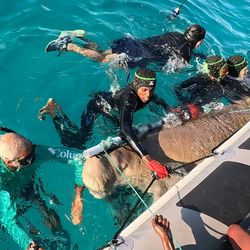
[{"left": 111, "top": 32, "right": 193, "bottom": 68}]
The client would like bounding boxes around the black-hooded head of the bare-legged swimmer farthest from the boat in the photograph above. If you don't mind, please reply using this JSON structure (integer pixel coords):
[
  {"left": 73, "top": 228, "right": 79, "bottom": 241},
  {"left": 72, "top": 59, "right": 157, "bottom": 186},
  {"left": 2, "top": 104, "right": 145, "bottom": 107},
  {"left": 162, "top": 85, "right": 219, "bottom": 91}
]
[{"left": 184, "top": 24, "right": 206, "bottom": 48}]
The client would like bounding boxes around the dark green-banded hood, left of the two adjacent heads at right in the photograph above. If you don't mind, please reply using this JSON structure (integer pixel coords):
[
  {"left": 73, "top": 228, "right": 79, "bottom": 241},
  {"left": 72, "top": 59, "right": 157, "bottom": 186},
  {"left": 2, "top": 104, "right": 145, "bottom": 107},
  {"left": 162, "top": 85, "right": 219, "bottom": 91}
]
[{"left": 204, "top": 56, "right": 227, "bottom": 79}]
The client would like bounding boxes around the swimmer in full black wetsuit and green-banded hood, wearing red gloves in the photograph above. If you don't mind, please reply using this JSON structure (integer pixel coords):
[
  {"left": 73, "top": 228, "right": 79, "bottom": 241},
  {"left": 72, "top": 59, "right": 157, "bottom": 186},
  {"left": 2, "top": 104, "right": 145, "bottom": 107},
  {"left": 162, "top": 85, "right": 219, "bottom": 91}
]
[{"left": 39, "top": 69, "right": 169, "bottom": 177}]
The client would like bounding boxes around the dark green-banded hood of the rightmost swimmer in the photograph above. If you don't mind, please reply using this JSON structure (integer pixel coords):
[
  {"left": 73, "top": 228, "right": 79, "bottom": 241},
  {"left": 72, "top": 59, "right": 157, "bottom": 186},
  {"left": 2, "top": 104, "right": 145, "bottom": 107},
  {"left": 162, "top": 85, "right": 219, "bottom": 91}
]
[{"left": 227, "top": 55, "right": 247, "bottom": 77}]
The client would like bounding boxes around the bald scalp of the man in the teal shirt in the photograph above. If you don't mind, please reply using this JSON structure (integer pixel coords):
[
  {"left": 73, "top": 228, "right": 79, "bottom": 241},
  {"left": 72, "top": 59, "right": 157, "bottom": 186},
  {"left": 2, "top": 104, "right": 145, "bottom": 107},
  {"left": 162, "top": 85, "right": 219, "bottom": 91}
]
[{"left": 0, "top": 133, "right": 32, "bottom": 160}]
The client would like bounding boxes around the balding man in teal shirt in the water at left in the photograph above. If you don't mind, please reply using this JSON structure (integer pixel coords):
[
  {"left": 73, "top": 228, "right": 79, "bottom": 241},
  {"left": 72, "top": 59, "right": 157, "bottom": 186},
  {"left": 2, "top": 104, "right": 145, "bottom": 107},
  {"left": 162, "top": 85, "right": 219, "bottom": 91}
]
[{"left": 0, "top": 127, "right": 72, "bottom": 250}]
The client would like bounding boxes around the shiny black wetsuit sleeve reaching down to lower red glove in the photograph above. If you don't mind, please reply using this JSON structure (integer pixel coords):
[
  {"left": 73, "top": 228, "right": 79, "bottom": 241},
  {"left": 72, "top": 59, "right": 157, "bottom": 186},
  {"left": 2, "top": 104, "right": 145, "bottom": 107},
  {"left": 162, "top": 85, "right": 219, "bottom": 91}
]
[{"left": 120, "top": 95, "right": 148, "bottom": 157}]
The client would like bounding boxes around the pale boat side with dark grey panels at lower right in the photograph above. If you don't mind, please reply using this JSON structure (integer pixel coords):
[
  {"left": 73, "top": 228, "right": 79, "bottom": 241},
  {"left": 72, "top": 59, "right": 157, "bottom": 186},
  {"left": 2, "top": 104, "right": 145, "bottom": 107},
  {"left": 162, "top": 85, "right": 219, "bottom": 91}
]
[{"left": 114, "top": 122, "right": 250, "bottom": 250}]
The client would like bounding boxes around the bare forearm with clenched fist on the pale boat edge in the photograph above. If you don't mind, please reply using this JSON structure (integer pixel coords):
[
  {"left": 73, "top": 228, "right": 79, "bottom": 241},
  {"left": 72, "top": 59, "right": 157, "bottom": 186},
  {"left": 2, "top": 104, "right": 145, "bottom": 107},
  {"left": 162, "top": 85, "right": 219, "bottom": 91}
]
[{"left": 151, "top": 215, "right": 174, "bottom": 250}]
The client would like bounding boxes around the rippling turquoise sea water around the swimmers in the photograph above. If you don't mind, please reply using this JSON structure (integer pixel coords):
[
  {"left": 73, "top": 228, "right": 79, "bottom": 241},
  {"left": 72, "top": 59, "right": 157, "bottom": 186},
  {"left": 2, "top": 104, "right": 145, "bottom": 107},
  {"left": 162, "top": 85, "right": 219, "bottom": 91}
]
[{"left": 0, "top": 0, "right": 250, "bottom": 250}]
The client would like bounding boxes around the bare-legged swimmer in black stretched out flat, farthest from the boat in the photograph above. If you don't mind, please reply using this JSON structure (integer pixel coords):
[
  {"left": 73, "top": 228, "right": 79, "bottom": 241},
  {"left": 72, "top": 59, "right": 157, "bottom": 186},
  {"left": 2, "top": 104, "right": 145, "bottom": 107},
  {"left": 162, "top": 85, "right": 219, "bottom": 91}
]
[{"left": 45, "top": 24, "right": 206, "bottom": 68}]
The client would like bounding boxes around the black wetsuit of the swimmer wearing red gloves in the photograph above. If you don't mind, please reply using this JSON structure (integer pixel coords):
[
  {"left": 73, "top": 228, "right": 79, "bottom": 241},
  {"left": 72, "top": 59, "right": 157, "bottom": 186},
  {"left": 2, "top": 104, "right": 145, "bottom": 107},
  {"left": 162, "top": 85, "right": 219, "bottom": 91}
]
[{"left": 53, "top": 85, "right": 169, "bottom": 157}]
